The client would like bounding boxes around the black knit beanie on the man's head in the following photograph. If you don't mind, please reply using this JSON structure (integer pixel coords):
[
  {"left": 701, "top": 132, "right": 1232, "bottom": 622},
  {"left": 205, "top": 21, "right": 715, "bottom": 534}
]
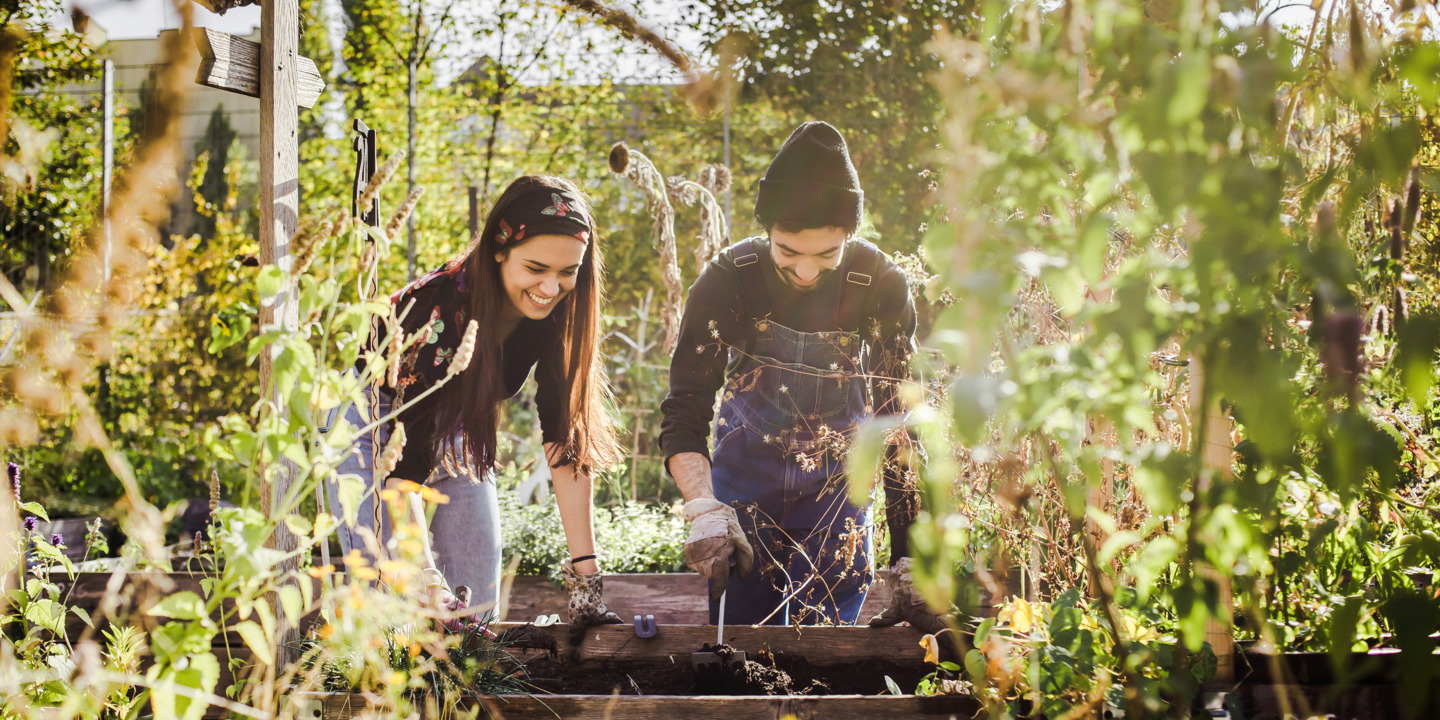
[{"left": 755, "top": 121, "right": 865, "bottom": 230}]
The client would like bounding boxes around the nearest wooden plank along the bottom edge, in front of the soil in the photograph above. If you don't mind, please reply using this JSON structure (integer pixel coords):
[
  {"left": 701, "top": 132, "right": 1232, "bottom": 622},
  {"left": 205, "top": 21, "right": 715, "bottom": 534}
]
[{"left": 311, "top": 694, "right": 981, "bottom": 720}]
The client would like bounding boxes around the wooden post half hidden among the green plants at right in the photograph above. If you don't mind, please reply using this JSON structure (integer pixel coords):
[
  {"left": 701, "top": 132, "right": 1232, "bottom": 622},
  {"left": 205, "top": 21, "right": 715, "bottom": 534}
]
[{"left": 1189, "top": 356, "right": 1236, "bottom": 685}]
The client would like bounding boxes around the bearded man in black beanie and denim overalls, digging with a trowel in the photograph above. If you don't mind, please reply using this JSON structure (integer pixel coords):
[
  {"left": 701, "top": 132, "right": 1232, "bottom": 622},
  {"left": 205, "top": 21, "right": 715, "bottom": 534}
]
[{"left": 660, "top": 122, "right": 942, "bottom": 631}]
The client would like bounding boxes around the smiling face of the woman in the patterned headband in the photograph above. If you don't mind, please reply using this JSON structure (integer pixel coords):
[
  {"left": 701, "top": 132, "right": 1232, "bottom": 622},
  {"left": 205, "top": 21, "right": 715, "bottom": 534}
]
[{"left": 495, "top": 235, "right": 589, "bottom": 320}]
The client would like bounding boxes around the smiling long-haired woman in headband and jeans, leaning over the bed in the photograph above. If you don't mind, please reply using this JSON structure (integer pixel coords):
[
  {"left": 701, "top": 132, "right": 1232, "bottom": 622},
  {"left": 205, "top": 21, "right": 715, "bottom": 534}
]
[{"left": 330, "top": 176, "right": 621, "bottom": 632}]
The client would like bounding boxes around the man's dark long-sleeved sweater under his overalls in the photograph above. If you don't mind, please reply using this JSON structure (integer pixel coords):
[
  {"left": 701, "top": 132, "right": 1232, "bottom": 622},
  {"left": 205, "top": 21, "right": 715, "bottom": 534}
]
[{"left": 660, "top": 238, "right": 919, "bottom": 557}]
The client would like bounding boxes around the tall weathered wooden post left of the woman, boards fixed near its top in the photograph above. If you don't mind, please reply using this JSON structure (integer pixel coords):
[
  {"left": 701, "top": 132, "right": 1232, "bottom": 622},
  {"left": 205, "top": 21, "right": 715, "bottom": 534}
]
[{"left": 259, "top": 0, "right": 300, "bottom": 668}]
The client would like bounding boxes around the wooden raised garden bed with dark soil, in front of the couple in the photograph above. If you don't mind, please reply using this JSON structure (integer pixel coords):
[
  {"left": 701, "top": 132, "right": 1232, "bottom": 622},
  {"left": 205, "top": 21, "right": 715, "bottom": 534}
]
[{"left": 312, "top": 624, "right": 979, "bottom": 720}]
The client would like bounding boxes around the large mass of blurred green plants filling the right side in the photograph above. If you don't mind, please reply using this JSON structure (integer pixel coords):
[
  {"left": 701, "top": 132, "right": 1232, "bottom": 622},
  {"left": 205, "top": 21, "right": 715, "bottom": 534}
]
[{"left": 858, "top": 0, "right": 1440, "bottom": 716}]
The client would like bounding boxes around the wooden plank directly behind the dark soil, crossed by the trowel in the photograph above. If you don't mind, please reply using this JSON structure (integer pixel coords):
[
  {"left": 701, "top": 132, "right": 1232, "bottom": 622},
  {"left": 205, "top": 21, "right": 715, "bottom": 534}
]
[{"left": 494, "top": 622, "right": 924, "bottom": 665}]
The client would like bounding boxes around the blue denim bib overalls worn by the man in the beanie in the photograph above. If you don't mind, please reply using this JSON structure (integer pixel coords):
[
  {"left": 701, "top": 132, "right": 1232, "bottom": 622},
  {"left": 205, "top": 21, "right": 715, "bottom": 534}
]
[{"left": 710, "top": 240, "right": 878, "bottom": 625}]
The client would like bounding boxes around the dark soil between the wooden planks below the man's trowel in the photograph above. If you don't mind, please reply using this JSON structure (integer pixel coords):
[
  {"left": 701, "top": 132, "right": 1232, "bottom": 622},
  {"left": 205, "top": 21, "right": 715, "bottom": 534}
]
[{"left": 512, "top": 647, "right": 933, "bottom": 696}]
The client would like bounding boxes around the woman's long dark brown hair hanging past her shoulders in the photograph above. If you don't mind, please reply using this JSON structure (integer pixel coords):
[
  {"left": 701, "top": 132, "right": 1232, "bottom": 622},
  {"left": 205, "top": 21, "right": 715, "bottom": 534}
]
[{"left": 435, "top": 176, "right": 621, "bottom": 480}]
